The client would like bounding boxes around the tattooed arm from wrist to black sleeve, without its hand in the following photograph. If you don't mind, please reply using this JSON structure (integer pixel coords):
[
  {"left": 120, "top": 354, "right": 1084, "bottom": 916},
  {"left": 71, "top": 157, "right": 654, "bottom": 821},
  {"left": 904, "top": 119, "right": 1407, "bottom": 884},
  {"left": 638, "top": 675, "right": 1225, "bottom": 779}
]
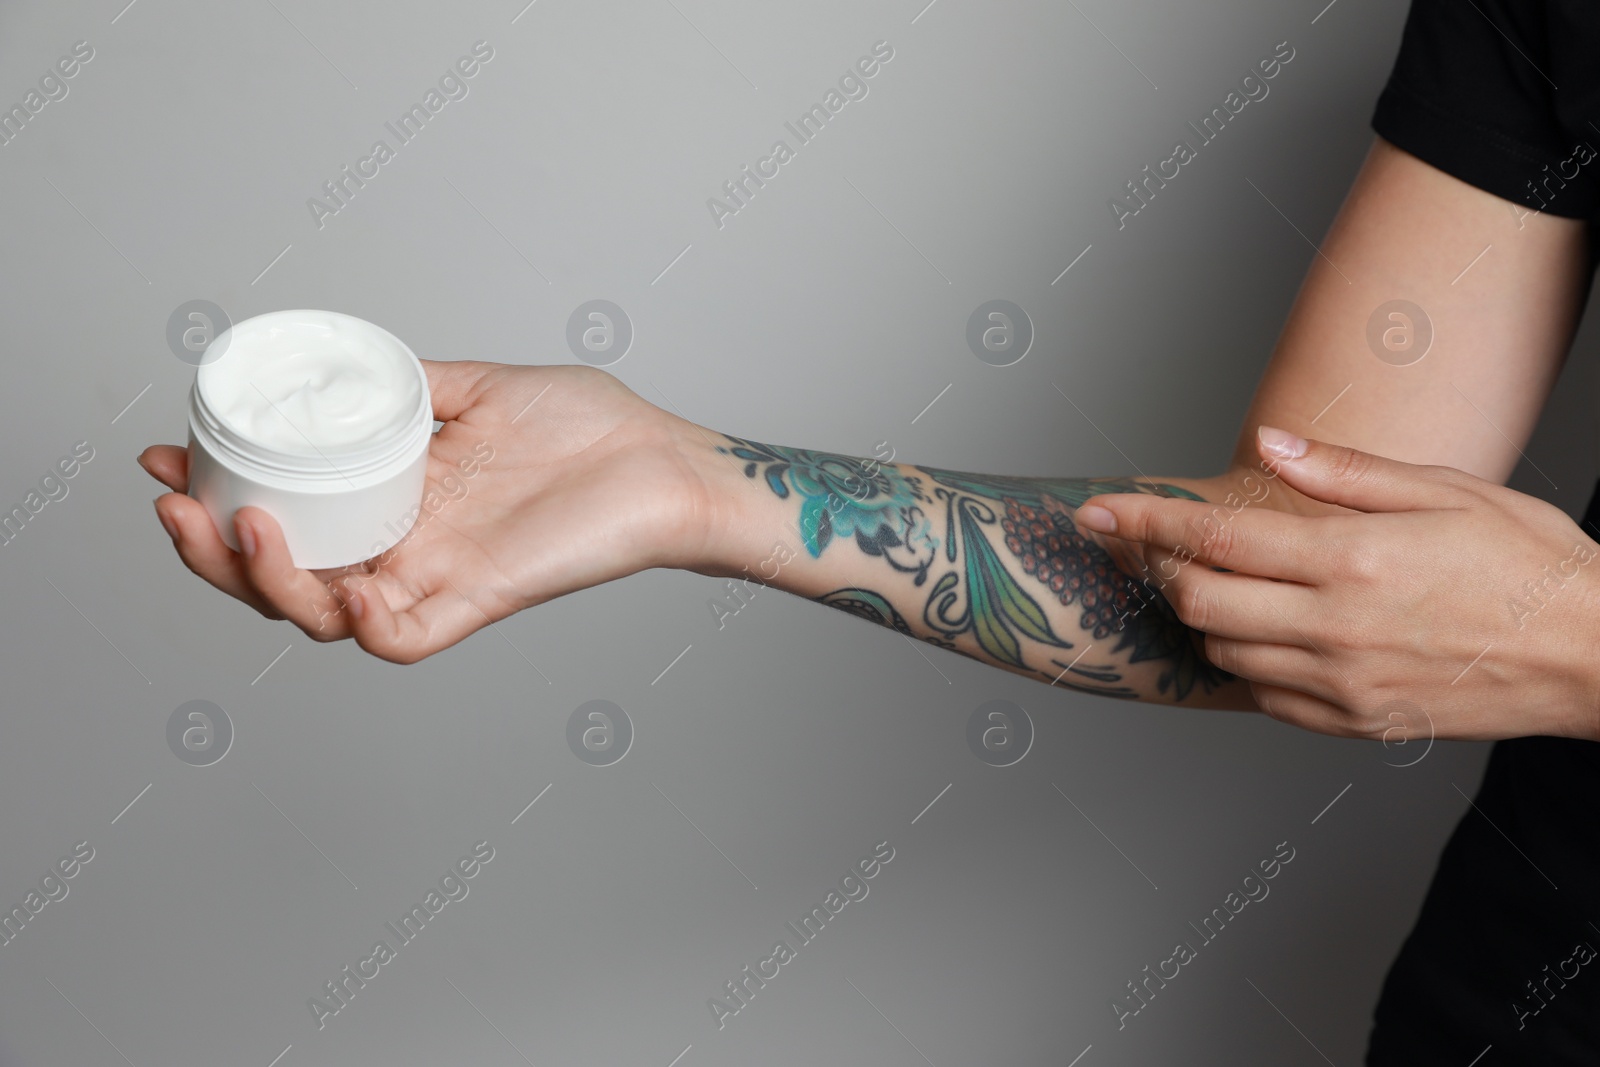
[{"left": 681, "top": 141, "right": 1587, "bottom": 707}]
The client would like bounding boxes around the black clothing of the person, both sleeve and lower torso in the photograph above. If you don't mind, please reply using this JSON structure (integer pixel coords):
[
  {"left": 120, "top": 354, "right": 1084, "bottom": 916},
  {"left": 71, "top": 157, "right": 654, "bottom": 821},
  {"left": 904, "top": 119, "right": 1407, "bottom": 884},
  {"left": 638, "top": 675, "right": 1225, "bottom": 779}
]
[{"left": 1366, "top": 0, "right": 1600, "bottom": 1067}]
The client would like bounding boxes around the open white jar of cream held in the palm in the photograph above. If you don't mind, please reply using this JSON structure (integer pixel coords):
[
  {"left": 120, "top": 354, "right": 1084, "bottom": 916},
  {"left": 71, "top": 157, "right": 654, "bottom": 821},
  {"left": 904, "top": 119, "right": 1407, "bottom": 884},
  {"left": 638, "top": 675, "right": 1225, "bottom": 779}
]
[{"left": 189, "top": 310, "right": 434, "bottom": 569}]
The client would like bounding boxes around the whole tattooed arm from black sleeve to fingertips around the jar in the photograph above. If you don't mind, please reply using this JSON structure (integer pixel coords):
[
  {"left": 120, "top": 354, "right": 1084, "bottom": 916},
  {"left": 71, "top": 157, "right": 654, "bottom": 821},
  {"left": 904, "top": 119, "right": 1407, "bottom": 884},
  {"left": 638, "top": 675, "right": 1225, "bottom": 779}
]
[{"left": 141, "top": 142, "right": 1584, "bottom": 726}]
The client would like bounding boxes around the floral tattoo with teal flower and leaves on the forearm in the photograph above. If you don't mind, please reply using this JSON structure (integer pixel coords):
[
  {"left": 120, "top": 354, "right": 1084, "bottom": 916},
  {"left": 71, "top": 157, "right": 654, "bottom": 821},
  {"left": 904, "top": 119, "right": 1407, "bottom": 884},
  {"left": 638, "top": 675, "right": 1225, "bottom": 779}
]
[{"left": 718, "top": 437, "right": 1232, "bottom": 701}]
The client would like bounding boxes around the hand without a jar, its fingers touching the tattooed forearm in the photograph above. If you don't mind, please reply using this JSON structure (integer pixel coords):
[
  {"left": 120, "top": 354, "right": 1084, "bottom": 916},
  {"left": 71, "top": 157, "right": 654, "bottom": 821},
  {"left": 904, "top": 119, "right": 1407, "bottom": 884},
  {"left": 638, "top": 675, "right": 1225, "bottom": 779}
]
[{"left": 1075, "top": 427, "right": 1600, "bottom": 741}]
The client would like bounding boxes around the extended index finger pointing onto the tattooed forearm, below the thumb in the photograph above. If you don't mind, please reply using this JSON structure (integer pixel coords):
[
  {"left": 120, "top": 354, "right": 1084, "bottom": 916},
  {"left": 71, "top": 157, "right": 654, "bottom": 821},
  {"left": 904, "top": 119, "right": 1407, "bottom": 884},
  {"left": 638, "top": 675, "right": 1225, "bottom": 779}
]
[{"left": 1074, "top": 493, "right": 1325, "bottom": 582}]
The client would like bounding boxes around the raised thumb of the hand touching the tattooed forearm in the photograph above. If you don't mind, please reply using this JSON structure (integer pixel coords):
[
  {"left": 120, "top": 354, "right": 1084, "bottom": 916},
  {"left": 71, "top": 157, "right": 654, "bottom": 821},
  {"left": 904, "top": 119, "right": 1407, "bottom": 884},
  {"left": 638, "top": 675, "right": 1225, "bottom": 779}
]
[{"left": 1256, "top": 426, "right": 1461, "bottom": 512}]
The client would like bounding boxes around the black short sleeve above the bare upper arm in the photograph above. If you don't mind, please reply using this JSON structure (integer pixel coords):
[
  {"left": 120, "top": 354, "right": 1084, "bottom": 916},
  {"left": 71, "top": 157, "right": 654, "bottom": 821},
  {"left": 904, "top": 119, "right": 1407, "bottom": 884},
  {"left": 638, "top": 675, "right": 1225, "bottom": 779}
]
[{"left": 1373, "top": 0, "right": 1600, "bottom": 221}]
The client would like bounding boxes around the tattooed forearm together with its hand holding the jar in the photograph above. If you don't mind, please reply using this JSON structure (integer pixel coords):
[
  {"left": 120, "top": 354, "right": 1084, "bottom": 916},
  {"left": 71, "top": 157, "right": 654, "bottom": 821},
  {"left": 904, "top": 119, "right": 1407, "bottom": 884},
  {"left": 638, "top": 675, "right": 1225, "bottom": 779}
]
[{"left": 141, "top": 362, "right": 1248, "bottom": 709}]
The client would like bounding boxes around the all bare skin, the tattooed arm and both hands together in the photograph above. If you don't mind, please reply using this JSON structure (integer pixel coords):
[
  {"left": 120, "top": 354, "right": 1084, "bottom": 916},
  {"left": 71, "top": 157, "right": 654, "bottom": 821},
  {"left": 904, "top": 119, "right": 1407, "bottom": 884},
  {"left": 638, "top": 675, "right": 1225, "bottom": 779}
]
[{"left": 139, "top": 141, "right": 1600, "bottom": 737}]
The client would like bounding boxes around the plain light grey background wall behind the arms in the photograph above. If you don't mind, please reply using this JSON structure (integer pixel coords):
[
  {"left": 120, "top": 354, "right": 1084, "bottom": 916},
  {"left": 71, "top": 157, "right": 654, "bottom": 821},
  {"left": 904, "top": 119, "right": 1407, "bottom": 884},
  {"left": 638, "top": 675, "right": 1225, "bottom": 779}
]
[{"left": 0, "top": 0, "right": 1595, "bottom": 1067}]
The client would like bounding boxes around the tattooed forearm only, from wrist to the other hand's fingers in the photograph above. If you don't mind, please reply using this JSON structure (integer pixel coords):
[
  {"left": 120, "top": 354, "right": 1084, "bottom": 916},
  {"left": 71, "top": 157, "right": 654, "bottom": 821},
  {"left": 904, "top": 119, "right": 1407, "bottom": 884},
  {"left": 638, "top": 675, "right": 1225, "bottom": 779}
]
[{"left": 681, "top": 432, "right": 1272, "bottom": 709}]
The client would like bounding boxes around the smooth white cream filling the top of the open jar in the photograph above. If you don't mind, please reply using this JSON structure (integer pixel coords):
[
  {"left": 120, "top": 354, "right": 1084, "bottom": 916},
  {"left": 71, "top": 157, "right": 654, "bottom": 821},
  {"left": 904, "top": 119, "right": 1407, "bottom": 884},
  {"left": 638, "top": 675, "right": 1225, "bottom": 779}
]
[{"left": 197, "top": 310, "right": 422, "bottom": 454}]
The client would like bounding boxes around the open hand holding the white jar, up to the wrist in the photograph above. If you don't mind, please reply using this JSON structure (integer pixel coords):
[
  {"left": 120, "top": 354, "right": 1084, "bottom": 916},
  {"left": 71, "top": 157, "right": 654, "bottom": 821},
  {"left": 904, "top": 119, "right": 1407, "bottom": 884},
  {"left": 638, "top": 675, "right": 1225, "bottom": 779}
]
[{"left": 139, "top": 360, "right": 712, "bottom": 662}]
